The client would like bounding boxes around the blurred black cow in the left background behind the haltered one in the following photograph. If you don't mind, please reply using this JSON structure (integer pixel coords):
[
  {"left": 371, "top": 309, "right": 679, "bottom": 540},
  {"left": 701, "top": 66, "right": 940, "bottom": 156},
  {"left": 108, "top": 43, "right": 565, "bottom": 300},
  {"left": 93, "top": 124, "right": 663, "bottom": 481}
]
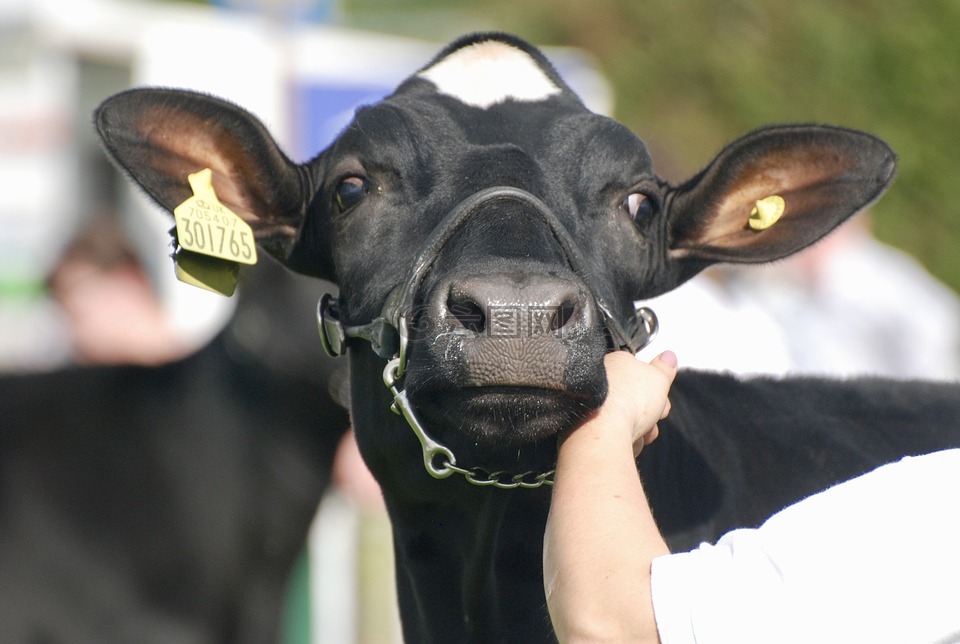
[{"left": 0, "top": 262, "right": 348, "bottom": 644}]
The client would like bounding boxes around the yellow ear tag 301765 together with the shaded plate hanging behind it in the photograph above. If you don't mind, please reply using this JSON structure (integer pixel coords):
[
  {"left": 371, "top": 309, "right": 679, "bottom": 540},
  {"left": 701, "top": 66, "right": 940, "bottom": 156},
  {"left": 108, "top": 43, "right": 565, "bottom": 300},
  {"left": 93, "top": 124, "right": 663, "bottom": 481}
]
[{"left": 171, "top": 168, "right": 257, "bottom": 297}]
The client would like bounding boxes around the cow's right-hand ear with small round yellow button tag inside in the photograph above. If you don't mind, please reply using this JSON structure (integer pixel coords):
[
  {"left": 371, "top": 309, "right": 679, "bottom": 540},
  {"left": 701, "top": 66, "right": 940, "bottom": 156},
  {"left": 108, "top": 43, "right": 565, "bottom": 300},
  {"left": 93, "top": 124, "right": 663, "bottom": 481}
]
[{"left": 667, "top": 125, "right": 896, "bottom": 281}]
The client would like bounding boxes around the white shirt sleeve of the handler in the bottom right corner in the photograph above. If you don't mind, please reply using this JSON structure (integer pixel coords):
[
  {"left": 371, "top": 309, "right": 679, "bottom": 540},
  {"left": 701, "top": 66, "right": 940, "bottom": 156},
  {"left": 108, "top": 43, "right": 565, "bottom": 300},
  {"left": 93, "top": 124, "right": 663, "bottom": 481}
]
[{"left": 651, "top": 450, "right": 960, "bottom": 644}]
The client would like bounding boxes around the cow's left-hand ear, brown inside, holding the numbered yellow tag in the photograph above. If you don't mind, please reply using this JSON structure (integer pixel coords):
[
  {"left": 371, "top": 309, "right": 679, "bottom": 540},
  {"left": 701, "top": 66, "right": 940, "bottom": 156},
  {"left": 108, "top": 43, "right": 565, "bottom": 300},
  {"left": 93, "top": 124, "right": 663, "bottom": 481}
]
[{"left": 94, "top": 89, "right": 329, "bottom": 277}]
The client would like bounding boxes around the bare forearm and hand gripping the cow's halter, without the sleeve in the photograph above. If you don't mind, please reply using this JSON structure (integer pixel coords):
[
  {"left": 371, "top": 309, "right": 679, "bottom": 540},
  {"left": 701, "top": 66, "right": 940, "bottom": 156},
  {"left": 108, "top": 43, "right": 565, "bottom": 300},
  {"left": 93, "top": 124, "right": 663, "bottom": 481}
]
[{"left": 544, "top": 352, "right": 676, "bottom": 642}]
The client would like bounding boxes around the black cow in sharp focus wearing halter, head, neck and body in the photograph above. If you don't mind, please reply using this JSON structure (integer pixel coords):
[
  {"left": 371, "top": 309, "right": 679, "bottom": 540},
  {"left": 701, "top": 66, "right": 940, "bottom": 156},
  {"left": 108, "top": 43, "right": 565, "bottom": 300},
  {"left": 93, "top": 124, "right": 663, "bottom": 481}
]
[{"left": 96, "top": 33, "right": 960, "bottom": 642}]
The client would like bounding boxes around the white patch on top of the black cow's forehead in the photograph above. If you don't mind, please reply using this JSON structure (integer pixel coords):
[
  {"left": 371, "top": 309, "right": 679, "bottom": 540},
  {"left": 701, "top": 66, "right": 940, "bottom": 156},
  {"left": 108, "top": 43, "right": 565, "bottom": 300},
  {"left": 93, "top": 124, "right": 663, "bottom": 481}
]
[{"left": 420, "top": 40, "right": 561, "bottom": 108}]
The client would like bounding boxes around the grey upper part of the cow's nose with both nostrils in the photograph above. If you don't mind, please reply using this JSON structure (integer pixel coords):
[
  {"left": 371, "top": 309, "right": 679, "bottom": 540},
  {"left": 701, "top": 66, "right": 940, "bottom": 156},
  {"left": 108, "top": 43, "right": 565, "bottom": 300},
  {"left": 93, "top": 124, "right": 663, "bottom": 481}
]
[{"left": 435, "top": 273, "right": 589, "bottom": 339}]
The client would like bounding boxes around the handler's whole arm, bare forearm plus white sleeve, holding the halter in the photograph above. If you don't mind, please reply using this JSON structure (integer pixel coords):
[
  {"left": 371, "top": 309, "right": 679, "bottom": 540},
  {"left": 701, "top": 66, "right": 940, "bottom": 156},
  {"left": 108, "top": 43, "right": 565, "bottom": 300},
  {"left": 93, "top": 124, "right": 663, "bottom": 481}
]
[{"left": 544, "top": 355, "right": 960, "bottom": 643}]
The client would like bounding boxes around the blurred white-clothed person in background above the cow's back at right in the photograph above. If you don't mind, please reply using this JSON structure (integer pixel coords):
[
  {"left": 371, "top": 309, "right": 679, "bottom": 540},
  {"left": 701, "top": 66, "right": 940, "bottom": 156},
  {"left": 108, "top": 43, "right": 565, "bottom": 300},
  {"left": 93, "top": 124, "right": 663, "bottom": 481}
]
[{"left": 641, "top": 214, "right": 960, "bottom": 380}]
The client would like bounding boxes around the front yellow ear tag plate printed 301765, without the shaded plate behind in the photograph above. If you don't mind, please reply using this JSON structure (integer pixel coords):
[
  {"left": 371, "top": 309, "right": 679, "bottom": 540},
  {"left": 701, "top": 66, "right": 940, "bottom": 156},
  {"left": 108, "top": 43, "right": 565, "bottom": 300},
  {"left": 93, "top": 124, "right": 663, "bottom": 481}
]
[{"left": 173, "top": 168, "right": 257, "bottom": 264}]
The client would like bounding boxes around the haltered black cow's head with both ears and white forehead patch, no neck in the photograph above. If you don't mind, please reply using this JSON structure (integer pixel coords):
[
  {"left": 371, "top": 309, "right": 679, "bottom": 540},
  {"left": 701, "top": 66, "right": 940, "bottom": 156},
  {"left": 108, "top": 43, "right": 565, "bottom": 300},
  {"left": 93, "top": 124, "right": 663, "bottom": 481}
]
[{"left": 96, "top": 34, "right": 895, "bottom": 487}]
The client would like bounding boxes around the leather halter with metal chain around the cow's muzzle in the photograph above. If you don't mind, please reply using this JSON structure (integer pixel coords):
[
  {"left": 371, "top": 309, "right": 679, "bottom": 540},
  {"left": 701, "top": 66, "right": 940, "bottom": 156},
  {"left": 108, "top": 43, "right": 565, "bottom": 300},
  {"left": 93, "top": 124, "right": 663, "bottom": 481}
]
[{"left": 317, "top": 186, "right": 658, "bottom": 489}]
